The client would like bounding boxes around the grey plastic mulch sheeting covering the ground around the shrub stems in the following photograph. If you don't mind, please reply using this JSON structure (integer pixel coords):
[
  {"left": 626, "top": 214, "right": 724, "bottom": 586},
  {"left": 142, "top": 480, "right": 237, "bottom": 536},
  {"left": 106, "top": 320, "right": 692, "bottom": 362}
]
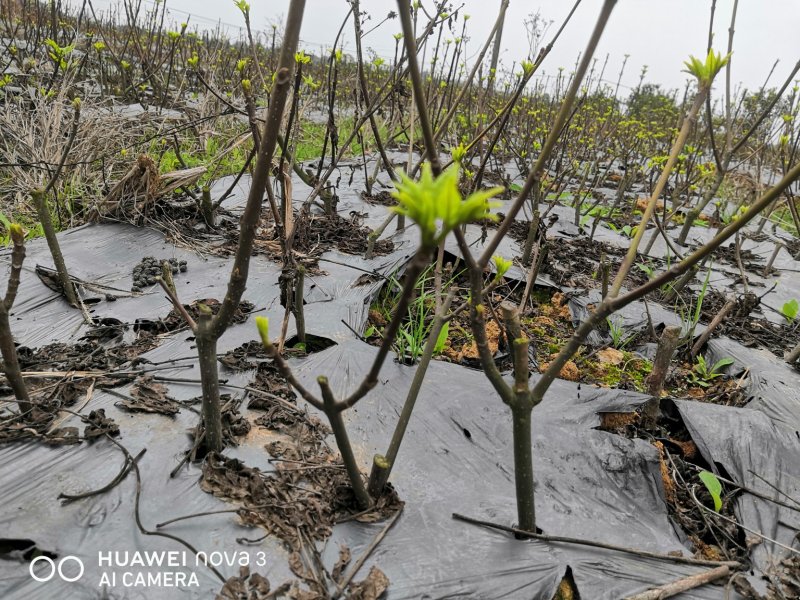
[{"left": 0, "top": 171, "right": 800, "bottom": 600}]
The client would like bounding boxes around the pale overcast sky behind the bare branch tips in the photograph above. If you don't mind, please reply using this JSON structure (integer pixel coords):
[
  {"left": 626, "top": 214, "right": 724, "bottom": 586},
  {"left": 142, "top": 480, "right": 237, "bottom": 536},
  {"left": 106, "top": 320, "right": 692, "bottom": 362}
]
[{"left": 83, "top": 0, "right": 800, "bottom": 95}]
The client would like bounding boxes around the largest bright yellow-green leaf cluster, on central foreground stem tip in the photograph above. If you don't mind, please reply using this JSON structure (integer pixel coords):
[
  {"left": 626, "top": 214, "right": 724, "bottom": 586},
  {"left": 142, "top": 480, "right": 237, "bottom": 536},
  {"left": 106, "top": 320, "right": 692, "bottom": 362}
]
[{"left": 392, "top": 163, "right": 503, "bottom": 250}]
